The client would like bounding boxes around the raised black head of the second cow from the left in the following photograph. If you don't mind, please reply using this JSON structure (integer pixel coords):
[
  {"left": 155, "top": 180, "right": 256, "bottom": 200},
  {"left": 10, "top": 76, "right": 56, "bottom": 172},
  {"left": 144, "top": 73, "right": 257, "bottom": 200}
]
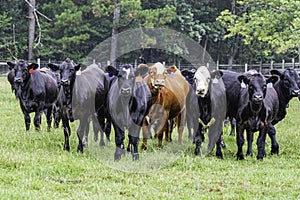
[{"left": 48, "top": 58, "right": 82, "bottom": 86}]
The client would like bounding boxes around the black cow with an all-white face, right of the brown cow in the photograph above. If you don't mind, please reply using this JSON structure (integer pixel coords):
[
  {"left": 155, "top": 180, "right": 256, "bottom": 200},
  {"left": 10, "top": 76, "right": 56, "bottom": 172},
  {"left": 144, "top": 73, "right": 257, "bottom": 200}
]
[{"left": 182, "top": 66, "right": 226, "bottom": 158}]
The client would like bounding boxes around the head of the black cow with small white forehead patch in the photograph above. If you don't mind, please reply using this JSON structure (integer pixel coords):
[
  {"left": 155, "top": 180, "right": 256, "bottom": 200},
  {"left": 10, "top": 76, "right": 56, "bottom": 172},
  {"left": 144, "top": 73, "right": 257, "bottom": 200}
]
[{"left": 106, "top": 64, "right": 148, "bottom": 97}]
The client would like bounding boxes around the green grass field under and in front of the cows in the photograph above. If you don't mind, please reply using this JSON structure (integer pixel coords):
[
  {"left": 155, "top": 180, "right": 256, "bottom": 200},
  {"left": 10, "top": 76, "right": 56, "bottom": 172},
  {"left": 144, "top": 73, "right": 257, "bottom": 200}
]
[{"left": 0, "top": 78, "right": 300, "bottom": 199}]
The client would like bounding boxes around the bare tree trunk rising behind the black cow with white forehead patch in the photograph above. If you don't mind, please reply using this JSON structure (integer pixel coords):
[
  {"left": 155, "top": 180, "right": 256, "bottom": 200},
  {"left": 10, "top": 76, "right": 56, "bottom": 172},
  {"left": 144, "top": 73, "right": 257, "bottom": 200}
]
[{"left": 110, "top": 0, "right": 120, "bottom": 66}]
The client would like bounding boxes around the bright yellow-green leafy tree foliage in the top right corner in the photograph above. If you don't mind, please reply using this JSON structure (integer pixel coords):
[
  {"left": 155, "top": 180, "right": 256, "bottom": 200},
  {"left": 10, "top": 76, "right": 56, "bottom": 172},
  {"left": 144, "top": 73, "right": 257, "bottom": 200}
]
[{"left": 218, "top": 0, "right": 300, "bottom": 59}]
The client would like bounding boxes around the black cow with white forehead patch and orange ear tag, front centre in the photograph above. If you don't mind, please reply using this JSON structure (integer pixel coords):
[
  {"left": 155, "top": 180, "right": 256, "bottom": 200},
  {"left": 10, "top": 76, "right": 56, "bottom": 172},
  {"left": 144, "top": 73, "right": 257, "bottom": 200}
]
[{"left": 106, "top": 64, "right": 151, "bottom": 160}]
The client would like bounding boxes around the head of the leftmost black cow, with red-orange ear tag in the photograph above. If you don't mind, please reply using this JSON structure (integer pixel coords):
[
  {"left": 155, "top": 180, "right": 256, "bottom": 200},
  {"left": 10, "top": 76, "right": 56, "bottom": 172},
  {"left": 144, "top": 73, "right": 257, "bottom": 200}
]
[{"left": 7, "top": 60, "right": 39, "bottom": 84}]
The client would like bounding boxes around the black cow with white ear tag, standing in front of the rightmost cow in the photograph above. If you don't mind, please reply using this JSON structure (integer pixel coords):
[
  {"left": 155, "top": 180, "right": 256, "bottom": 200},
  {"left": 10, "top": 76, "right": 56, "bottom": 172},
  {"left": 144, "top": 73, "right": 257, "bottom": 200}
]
[{"left": 236, "top": 73, "right": 279, "bottom": 160}]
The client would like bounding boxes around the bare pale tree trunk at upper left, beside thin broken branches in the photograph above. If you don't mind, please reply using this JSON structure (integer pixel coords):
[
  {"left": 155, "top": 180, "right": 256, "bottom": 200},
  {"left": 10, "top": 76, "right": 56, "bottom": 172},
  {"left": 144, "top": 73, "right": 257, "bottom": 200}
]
[{"left": 28, "top": 0, "right": 35, "bottom": 61}]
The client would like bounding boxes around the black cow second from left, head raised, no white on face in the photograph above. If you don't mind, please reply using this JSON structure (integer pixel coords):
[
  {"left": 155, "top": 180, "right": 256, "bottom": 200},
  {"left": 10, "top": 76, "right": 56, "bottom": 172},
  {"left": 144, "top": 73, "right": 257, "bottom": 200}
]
[{"left": 48, "top": 58, "right": 105, "bottom": 152}]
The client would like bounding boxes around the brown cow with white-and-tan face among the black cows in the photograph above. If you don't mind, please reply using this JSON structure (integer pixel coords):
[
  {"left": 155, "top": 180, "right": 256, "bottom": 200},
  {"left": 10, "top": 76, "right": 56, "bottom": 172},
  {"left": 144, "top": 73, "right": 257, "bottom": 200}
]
[{"left": 142, "top": 63, "right": 189, "bottom": 149}]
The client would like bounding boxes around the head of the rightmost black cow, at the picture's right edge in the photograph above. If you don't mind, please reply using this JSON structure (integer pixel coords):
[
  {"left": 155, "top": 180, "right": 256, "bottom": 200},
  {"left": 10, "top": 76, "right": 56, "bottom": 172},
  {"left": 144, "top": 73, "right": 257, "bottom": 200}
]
[{"left": 270, "top": 69, "right": 300, "bottom": 97}]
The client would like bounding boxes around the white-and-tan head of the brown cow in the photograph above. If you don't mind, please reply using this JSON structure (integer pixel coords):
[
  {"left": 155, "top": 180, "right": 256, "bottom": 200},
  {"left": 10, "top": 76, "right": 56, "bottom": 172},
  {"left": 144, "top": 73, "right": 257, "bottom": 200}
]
[{"left": 149, "top": 62, "right": 177, "bottom": 89}]
